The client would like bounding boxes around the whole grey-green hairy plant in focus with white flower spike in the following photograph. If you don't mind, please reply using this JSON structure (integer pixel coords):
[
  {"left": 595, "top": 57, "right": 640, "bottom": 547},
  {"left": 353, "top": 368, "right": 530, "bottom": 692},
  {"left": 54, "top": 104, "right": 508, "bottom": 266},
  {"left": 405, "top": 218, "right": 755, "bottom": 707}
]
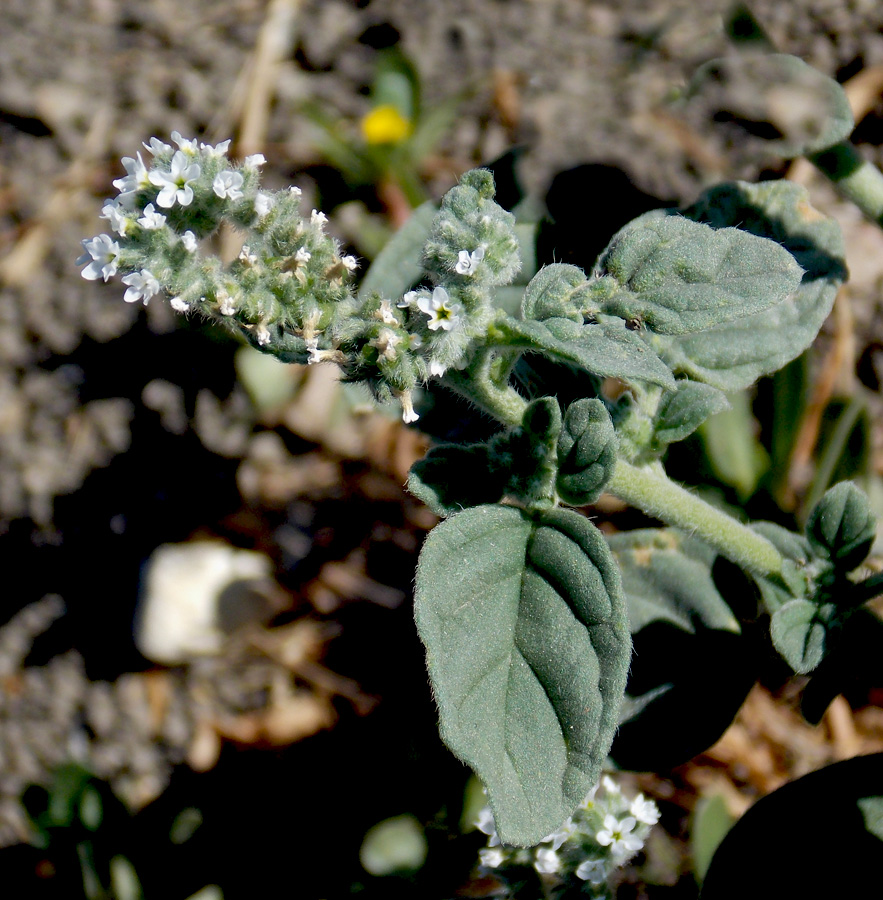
[{"left": 81, "top": 52, "right": 879, "bottom": 888}]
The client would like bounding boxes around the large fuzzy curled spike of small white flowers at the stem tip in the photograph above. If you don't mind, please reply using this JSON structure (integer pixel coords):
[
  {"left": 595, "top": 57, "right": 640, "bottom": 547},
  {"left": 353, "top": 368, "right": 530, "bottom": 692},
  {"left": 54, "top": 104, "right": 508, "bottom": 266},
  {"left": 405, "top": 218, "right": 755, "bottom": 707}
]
[{"left": 77, "top": 132, "right": 521, "bottom": 422}]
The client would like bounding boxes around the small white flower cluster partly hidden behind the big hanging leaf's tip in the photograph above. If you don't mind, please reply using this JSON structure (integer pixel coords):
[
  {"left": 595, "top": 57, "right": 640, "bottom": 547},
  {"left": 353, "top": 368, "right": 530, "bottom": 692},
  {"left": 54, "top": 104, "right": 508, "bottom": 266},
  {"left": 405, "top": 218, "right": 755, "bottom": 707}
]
[{"left": 476, "top": 775, "right": 659, "bottom": 896}]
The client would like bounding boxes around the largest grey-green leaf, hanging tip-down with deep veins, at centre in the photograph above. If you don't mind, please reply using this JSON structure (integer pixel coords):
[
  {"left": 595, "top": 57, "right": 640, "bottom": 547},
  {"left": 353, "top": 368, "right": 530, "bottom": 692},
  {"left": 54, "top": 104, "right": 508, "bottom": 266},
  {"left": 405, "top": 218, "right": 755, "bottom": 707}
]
[{"left": 415, "top": 506, "right": 631, "bottom": 846}]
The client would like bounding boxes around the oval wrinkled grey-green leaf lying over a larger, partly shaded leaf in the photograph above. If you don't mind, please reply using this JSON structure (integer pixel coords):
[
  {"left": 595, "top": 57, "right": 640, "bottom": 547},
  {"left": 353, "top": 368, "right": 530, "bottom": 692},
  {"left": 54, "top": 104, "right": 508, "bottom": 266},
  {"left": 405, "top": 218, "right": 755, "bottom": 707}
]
[{"left": 594, "top": 215, "right": 802, "bottom": 335}]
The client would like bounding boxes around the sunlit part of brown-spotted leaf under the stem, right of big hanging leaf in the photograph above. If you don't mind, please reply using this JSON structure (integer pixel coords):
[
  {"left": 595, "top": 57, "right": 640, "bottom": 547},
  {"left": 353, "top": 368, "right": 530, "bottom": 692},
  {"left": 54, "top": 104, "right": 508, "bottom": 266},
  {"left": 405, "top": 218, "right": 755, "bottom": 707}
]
[{"left": 607, "top": 528, "right": 740, "bottom": 634}]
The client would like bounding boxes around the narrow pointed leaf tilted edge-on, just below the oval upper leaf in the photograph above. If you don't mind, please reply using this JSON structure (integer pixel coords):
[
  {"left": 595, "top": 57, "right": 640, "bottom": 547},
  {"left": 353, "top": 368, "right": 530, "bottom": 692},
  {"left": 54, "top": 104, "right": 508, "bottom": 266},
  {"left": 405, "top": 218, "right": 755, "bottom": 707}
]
[{"left": 494, "top": 317, "right": 675, "bottom": 389}]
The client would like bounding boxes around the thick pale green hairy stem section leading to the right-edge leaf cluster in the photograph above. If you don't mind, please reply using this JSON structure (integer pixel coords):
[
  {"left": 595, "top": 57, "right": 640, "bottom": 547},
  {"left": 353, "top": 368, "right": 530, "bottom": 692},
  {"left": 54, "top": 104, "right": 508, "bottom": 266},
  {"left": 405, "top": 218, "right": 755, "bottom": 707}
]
[{"left": 606, "top": 459, "right": 785, "bottom": 579}]
